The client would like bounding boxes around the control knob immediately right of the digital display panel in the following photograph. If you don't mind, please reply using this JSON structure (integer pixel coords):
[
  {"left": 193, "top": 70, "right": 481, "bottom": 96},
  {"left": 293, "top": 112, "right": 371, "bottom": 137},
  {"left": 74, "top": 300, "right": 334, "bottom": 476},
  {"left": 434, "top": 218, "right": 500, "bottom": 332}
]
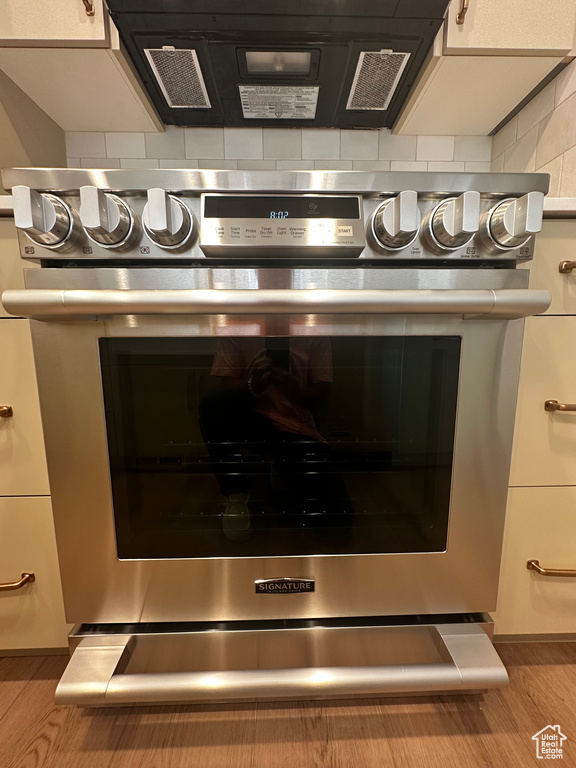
[{"left": 372, "top": 190, "right": 420, "bottom": 251}]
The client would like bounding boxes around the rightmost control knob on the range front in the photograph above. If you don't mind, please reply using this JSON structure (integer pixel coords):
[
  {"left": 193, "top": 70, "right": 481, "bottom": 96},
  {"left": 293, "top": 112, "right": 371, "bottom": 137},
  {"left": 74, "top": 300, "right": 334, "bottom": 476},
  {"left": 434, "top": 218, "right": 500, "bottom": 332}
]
[{"left": 483, "top": 192, "right": 544, "bottom": 251}]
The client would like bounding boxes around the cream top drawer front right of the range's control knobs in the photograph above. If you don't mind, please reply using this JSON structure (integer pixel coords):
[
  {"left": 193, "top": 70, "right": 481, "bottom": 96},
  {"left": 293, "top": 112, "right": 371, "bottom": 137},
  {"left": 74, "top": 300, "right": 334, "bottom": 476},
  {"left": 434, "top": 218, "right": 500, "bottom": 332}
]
[{"left": 523, "top": 220, "right": 576, "bottom": 315}]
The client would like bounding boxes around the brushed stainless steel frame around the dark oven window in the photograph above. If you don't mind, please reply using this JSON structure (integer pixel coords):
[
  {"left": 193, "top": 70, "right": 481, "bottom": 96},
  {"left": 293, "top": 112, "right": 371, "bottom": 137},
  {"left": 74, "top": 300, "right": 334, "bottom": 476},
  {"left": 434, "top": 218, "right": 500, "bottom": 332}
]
[{"left": 18, "top": 270, "right": 540, "bottom": 623}]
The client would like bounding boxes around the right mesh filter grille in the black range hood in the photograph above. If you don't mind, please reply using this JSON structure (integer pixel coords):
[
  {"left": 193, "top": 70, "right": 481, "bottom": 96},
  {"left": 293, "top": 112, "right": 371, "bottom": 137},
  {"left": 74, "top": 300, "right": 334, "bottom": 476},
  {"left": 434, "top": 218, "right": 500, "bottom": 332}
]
[{"left": 346, "top": 50, "right": 410, "bottom": 111}]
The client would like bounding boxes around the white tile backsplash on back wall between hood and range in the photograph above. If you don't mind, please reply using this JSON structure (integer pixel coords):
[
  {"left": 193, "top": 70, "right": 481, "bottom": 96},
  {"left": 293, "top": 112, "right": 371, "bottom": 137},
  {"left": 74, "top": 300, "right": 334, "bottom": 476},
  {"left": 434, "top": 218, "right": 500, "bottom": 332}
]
[{"left": 66, "top": 126, "right": 492, "bottom": 172}]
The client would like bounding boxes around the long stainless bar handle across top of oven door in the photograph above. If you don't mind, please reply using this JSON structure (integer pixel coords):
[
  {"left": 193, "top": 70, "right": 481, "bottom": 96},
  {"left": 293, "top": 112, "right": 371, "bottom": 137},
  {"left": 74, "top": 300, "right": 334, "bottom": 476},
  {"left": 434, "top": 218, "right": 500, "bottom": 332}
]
[{"left": 2, "top": 288, "right": 551, "bottom": 320}]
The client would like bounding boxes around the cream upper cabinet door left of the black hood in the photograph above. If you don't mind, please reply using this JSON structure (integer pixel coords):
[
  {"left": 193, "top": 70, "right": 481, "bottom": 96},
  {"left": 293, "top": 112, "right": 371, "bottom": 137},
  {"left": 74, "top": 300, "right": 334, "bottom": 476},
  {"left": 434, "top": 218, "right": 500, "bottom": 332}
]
[{"left": 0, "top": 0, "right": 108, "bottom": 47}]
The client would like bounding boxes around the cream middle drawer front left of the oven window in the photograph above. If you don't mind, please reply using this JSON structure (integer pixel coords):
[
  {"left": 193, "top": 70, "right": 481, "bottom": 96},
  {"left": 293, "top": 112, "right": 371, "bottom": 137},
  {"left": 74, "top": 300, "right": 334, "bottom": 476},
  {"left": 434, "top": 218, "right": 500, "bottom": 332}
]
[{"left": 0, "top": 319, "right": 50, "bottom": 496}]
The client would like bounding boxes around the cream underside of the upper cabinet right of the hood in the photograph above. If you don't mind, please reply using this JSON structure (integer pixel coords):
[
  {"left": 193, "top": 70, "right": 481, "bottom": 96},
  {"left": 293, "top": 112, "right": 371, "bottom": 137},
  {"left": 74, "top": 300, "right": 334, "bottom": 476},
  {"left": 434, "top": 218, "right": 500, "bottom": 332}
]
[{"left": 394, "top": 49, "right": 561, "bottom": 136}]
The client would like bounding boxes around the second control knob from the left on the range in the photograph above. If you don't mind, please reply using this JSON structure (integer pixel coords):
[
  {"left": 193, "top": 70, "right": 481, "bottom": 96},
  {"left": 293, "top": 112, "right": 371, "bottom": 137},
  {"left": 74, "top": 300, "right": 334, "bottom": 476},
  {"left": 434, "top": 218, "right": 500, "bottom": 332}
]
[{"left": 80, "top": 186, "right": 138, "bottom": 248}]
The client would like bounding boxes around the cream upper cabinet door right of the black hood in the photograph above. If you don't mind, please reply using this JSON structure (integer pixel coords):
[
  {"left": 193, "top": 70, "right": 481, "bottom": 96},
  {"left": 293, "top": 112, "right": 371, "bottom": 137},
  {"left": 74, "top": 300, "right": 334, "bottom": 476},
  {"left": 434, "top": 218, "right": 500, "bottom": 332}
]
[{"left": 444, "top": 0, "right": 576, "bottom": 55}]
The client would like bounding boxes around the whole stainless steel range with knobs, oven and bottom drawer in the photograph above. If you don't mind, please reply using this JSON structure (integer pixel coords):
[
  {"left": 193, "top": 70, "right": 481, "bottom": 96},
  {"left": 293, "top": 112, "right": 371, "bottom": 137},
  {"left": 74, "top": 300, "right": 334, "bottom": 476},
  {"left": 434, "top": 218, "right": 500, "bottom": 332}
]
[{"left": 3, "top": 169, "right": 550, "bottom": 705}]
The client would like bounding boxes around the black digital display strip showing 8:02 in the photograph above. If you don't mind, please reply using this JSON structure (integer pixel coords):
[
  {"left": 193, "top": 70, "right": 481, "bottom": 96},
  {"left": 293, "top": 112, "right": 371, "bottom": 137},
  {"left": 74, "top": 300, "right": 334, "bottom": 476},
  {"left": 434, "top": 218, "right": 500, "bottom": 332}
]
[{"left": 204, "top": 195, "right": 360, "bottom": 219}]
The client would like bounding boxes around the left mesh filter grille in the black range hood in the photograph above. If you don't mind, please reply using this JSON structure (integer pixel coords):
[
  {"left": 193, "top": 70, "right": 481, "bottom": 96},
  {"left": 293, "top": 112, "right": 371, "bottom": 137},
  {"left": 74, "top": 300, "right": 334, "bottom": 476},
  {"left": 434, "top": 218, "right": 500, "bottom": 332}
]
[{"left": 144, "top": 45, "right": 212, "bottom": 109}]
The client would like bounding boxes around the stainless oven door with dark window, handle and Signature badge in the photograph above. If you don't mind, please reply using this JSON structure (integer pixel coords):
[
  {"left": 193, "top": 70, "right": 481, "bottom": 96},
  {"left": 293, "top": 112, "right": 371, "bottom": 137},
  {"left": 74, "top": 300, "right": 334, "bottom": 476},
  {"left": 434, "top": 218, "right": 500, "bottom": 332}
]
[{"left": 4, "top": 268, "right": 549, "bottom": 624}]
